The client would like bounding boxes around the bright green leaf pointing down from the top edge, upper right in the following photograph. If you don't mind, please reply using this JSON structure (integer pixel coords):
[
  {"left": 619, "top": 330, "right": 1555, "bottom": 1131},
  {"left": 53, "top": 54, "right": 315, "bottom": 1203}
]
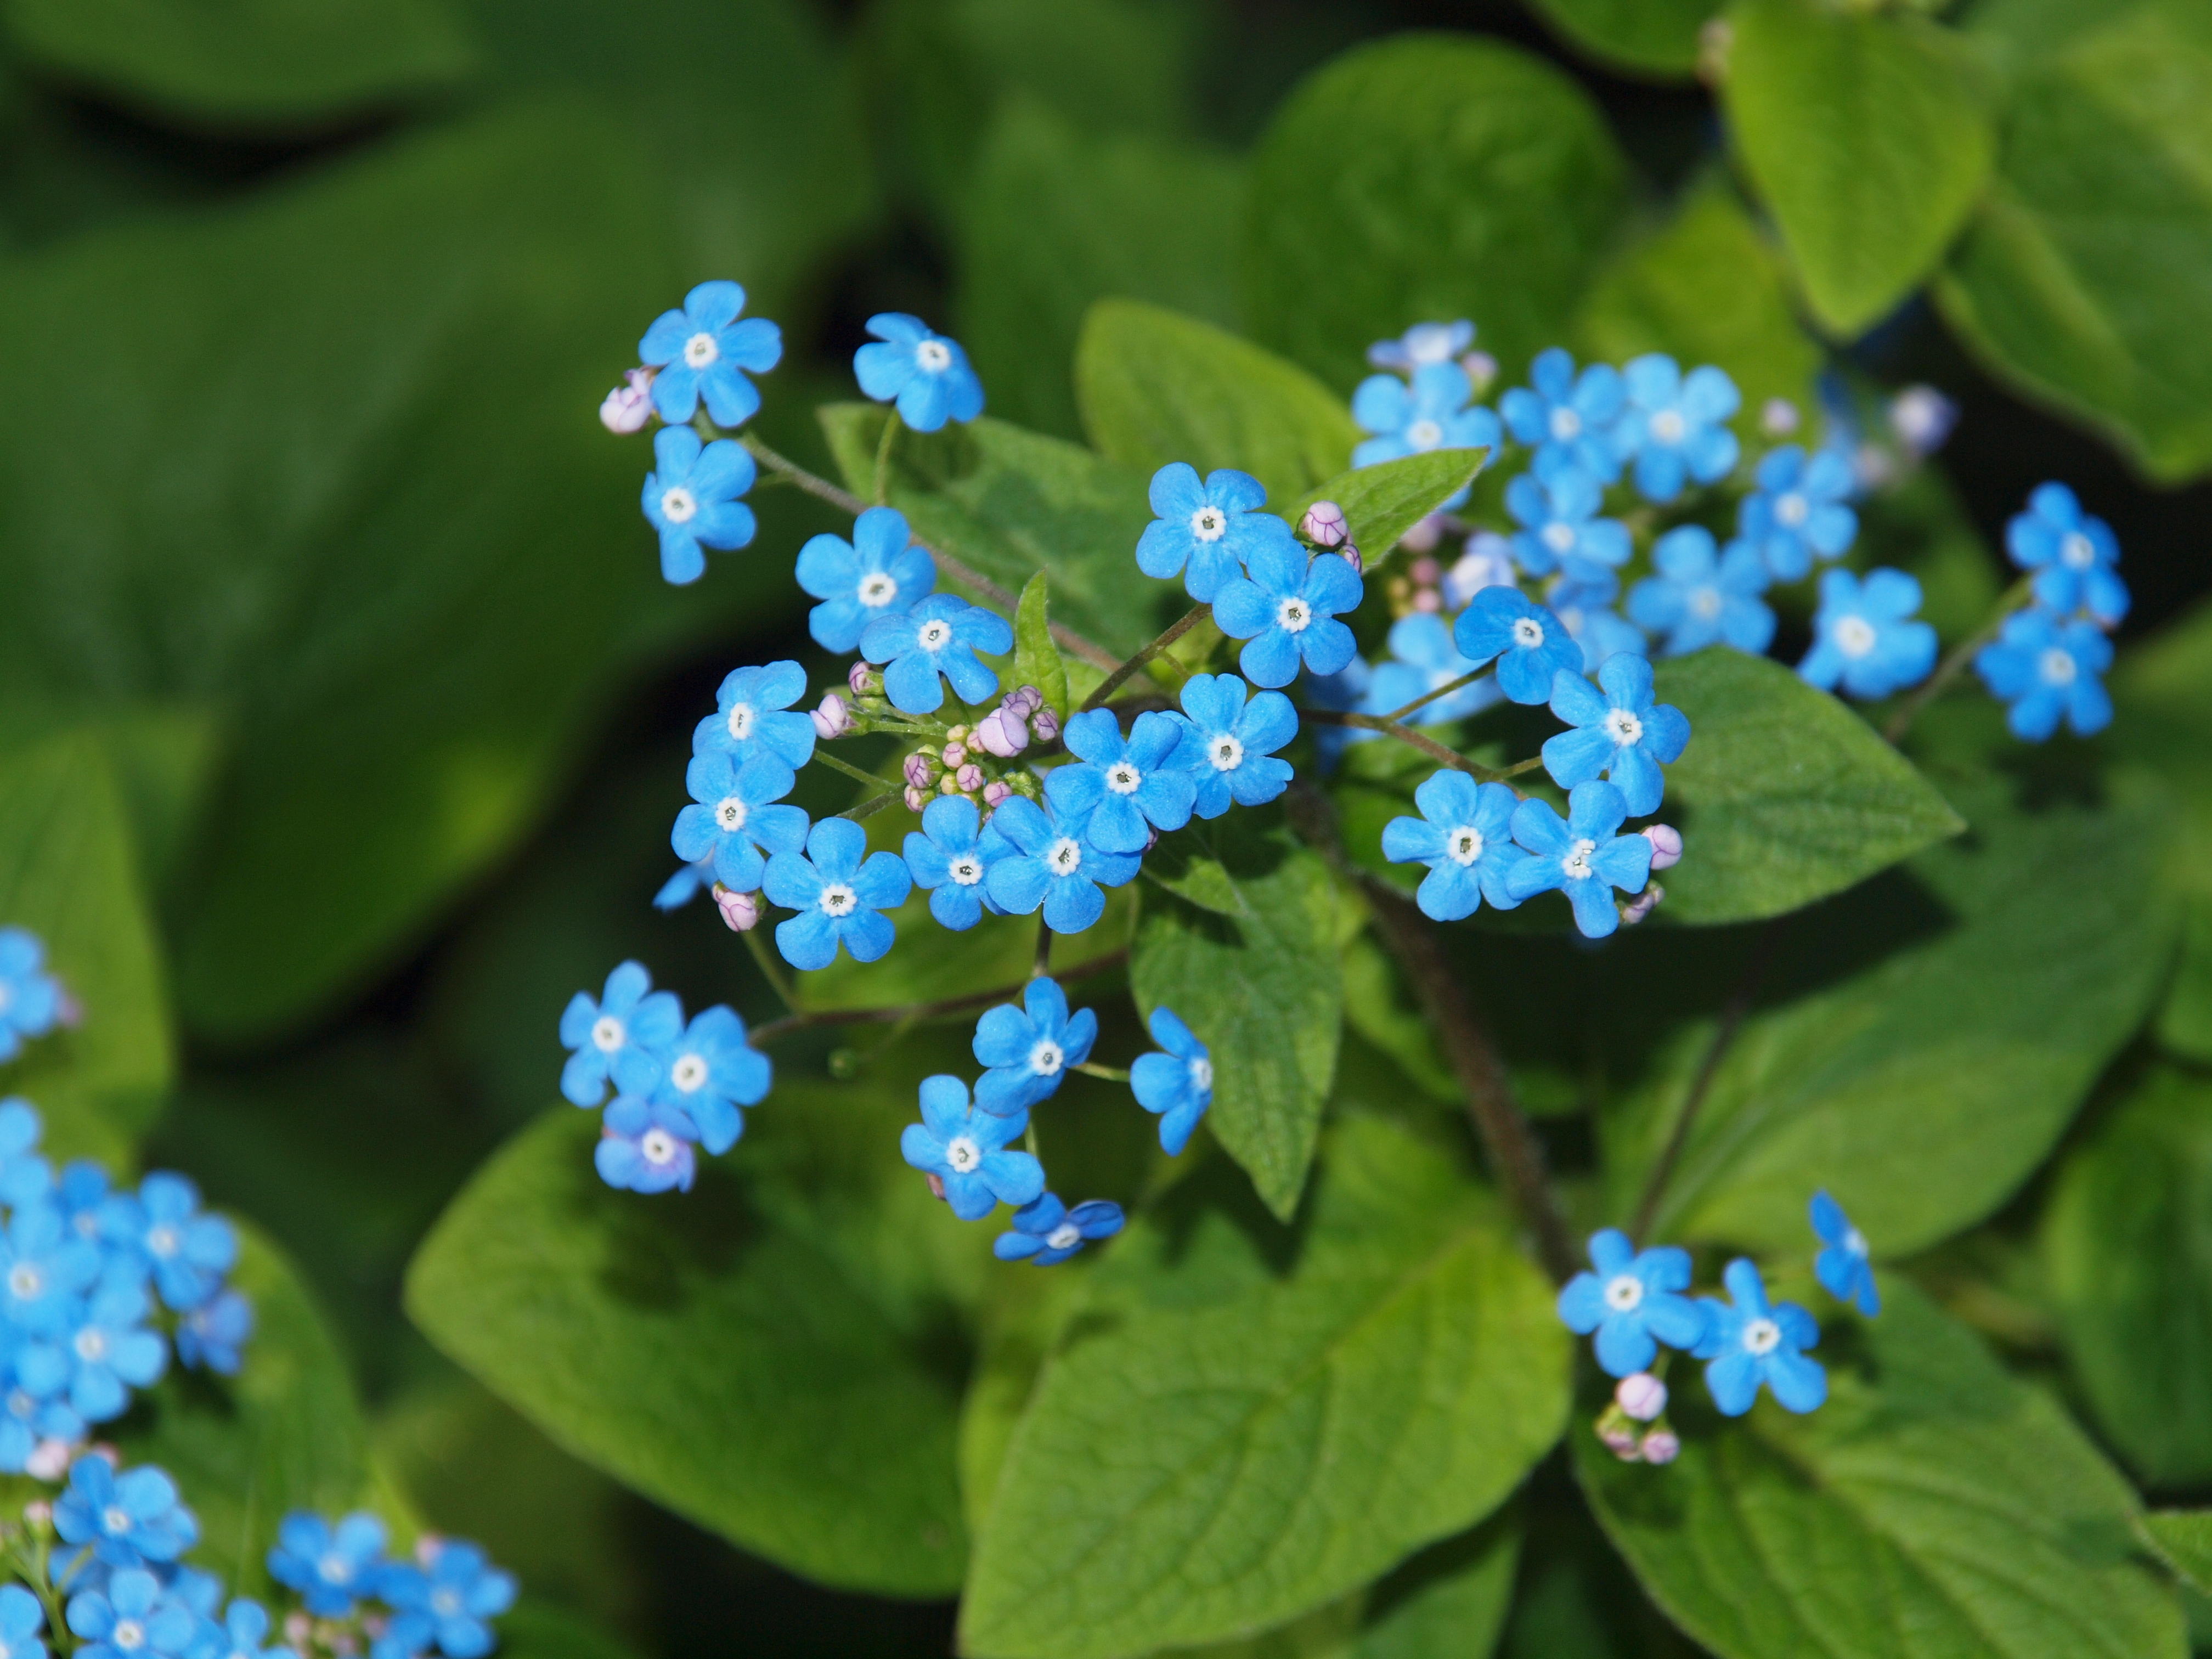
[{"left": 1725, "top": 0, "right": 1997, "bottom": 336}]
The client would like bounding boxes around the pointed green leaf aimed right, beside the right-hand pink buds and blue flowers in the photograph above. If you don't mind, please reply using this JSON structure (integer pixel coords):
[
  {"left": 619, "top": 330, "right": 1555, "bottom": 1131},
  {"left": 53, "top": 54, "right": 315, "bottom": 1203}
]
[{"left": 1659, "top": 648, "right": 1964, "bottom": 922}]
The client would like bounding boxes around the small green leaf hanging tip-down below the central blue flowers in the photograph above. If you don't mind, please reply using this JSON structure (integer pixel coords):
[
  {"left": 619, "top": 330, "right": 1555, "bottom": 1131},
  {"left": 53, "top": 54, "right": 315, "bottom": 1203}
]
[{"left": 1128, "top": 812, "right": 1345, "bottom": 1219}]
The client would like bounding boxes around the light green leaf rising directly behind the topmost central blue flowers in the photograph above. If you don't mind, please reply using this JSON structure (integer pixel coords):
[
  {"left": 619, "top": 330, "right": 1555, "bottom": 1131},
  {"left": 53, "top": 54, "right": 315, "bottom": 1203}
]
[{"left": 1075, "top": 298, "right": 1363, "bottom": 504}]
